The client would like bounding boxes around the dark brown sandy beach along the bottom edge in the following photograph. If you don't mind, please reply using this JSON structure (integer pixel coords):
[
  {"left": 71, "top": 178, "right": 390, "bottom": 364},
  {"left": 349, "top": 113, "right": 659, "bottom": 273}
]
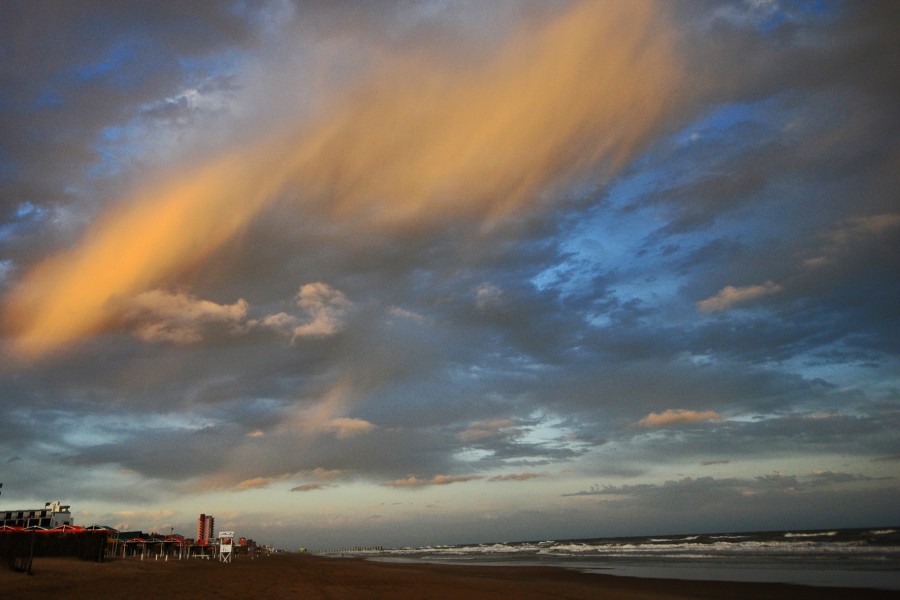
[{"left": 0, "top": 555, "right": 900, "bottom": 600}]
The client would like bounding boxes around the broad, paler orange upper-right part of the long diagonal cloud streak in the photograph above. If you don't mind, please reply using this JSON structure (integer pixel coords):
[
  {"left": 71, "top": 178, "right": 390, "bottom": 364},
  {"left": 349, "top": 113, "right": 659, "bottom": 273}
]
[{"left": 298, "top": 2, "right": 681, "bottom": 225}]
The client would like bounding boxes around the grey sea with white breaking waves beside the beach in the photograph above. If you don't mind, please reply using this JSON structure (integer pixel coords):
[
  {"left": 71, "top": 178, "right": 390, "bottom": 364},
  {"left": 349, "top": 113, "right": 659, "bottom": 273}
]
[{"left": 332, "top": 527, "right": 900, "bottom": 590}]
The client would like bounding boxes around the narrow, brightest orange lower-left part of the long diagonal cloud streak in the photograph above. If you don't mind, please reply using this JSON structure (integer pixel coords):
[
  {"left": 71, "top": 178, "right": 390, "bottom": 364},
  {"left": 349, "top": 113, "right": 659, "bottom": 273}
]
[{"left": 3, "top": 142, "right": 283, "bottom": 357}]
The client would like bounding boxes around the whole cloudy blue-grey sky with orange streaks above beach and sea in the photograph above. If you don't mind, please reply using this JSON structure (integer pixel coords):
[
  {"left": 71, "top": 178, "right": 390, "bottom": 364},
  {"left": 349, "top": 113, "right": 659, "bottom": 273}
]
[{"left": 0, "top": 0, "right": 900, "bottom": 549}]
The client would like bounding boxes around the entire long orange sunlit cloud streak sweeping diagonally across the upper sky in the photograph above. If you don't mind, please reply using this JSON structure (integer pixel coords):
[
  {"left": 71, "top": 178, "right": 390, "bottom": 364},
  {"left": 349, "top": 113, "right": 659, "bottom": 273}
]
[{"left": 3, "top": 2, "right": 681, "bottom": 359}]
